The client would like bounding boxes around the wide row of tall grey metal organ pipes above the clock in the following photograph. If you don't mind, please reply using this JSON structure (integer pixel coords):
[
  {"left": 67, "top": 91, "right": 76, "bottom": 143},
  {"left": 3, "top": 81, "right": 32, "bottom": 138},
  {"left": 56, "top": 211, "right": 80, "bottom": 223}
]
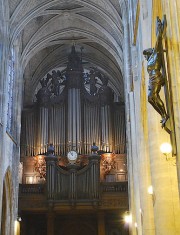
[{"left": 22, "top": 94, "right": 126, "bottom": 156}]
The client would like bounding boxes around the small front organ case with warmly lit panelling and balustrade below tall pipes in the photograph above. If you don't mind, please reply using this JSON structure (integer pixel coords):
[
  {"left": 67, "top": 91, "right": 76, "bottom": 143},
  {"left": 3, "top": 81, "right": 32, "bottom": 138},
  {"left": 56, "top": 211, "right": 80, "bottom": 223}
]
[{"left": 19, "top": 150, "right": 128, "bottom": 210}]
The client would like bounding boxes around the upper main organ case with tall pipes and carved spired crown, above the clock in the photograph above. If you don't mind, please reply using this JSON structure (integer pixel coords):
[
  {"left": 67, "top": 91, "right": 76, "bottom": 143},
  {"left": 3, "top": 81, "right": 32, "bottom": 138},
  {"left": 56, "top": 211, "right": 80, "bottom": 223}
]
[{"left": 21, "top": 46, "right": 125, "bottom": 156}]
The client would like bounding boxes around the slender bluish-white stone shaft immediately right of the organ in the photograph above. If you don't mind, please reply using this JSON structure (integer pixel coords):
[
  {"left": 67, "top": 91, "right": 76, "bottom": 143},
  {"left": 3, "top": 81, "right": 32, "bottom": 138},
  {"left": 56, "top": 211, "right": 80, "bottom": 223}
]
[{"left": 120, "top": 0, "right": 141, "bottom": 235}]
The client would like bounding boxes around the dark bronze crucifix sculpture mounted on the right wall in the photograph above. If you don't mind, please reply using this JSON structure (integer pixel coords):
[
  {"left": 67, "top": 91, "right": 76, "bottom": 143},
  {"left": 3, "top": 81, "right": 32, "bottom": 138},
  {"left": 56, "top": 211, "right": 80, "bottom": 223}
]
[{"left": 143, "top": 15, "right": 177, "bottom": 155}]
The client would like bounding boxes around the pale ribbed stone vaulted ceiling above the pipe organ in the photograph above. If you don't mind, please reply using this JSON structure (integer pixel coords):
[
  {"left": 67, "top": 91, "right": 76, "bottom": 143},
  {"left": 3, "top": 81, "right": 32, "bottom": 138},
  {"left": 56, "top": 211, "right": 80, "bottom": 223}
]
[{"left": 9, "top": 0, "right": 124, "bottom": 103}]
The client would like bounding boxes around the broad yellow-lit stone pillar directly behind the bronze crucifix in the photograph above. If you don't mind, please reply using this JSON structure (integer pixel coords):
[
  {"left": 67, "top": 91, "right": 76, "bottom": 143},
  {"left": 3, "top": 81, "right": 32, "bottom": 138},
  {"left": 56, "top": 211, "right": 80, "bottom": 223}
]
[{"left": 148, "top": 0, "right": 180, "bottom": 235}]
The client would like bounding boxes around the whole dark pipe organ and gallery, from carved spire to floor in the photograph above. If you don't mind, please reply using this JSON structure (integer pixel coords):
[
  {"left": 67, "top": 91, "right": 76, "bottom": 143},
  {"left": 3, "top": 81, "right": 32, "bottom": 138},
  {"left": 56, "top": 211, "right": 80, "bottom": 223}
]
[{"left": 19, "top": 46, "right": 128, "bottom": 235}]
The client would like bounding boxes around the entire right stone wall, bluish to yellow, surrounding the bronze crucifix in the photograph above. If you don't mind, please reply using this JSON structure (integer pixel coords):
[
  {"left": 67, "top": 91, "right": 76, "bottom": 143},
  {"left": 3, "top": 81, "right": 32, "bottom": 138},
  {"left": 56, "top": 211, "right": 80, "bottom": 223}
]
[{"left": 124, "top": 0, "right": 180, "bottom": 235}]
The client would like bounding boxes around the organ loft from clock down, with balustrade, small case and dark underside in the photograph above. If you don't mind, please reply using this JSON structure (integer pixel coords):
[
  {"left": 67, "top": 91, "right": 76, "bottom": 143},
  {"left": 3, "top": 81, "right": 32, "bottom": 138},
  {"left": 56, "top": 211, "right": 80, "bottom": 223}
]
[{"left": 19, "top": 147, "right": 128, "bottom": 235}]
